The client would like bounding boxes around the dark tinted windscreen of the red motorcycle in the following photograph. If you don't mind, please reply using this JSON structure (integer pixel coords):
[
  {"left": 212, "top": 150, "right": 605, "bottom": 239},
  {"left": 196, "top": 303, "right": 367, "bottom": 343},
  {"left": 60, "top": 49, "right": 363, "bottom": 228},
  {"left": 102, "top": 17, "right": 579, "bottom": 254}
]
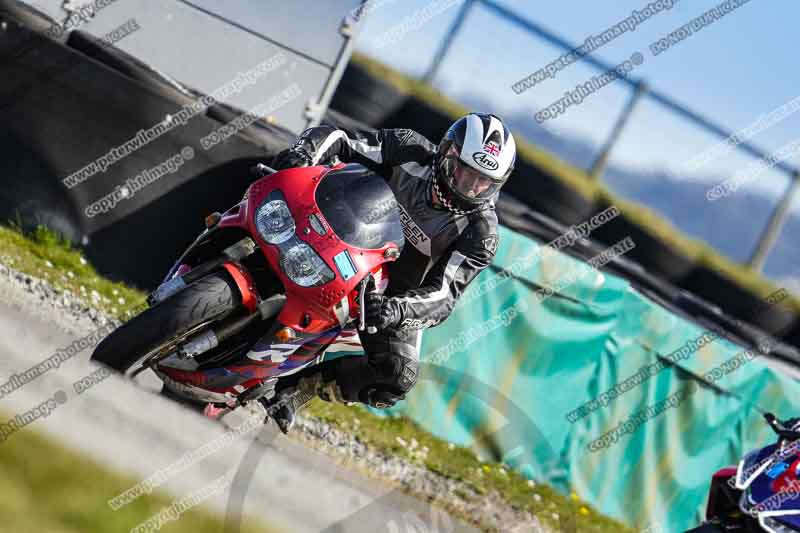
[{"left": 316, "top": 164, "right": 405, "bottom": 250}]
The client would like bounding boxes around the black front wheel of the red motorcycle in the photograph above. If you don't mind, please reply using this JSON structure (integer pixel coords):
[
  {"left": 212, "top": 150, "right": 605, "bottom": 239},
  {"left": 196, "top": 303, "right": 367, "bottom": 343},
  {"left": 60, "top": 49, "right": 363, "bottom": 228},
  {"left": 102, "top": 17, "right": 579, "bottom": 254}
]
[{"left": 92, "top": 272, "right": 241, "bottom": 375}]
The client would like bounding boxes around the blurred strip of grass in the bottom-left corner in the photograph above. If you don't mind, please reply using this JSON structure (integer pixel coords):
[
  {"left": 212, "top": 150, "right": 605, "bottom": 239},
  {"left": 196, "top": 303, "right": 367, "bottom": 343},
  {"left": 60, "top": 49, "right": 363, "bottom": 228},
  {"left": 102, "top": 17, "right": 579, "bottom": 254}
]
[{"left": 0, "top": 416, "right": 275, "bottom": 533}]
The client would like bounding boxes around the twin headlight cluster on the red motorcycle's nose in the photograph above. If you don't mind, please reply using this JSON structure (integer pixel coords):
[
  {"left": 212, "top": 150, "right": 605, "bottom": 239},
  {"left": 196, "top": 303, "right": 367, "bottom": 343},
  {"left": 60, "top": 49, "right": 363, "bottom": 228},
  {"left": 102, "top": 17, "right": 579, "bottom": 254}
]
[{"left": 255, "top": 191, "right": 336, "bottom": 287}]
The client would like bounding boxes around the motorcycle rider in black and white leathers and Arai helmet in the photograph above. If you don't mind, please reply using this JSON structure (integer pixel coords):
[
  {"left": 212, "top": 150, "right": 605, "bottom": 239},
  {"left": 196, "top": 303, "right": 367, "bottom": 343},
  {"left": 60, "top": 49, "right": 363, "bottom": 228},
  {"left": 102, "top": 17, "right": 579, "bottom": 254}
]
[{"left": 266, "top": 113, "right": 516, "bottom": 433}]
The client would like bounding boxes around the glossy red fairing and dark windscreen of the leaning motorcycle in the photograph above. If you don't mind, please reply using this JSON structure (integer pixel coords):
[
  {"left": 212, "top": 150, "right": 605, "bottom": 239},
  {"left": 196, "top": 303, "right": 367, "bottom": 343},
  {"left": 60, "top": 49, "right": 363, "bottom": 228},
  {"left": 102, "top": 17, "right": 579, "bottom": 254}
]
[{"left": 159, "top": 164, "right": 405, "bottom": 402}]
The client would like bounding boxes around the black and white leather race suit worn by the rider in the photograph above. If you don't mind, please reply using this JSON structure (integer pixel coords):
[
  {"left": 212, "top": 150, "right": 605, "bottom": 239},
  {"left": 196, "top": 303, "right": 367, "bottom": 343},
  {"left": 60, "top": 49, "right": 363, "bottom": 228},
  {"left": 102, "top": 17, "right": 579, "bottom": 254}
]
[{"left": 278, "top": 126, "right": 498, "bottom": 407}]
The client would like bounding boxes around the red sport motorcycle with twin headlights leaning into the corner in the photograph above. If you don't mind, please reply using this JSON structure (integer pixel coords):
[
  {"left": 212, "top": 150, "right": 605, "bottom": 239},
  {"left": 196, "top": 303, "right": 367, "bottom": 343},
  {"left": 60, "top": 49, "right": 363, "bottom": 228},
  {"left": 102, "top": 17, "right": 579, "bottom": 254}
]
[{"left": 92, "top": 163, "right": 404, "bottom": 418}]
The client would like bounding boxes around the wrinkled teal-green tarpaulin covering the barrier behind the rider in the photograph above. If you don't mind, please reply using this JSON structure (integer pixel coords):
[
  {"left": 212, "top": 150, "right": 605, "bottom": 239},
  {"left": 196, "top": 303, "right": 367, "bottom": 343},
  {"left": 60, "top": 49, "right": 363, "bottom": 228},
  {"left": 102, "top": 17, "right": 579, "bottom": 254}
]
[{"left": 328, "top": 228, "right": 800, "bottom": 532}]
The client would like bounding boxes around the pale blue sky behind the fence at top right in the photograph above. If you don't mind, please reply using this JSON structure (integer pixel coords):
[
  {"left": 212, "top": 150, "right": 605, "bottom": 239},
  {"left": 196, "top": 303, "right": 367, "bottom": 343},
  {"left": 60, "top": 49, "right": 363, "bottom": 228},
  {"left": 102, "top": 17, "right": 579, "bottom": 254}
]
[{"left": 356, "top": 0, "right": 800, "bottom": 204}]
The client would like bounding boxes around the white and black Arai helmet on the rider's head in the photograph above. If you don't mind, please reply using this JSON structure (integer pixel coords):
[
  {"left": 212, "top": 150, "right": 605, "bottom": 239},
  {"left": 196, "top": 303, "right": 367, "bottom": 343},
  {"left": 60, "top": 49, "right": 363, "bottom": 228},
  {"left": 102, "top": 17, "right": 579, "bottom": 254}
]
[{"left": 433, "top": 113, "right": 517, "bottom": 213}]
